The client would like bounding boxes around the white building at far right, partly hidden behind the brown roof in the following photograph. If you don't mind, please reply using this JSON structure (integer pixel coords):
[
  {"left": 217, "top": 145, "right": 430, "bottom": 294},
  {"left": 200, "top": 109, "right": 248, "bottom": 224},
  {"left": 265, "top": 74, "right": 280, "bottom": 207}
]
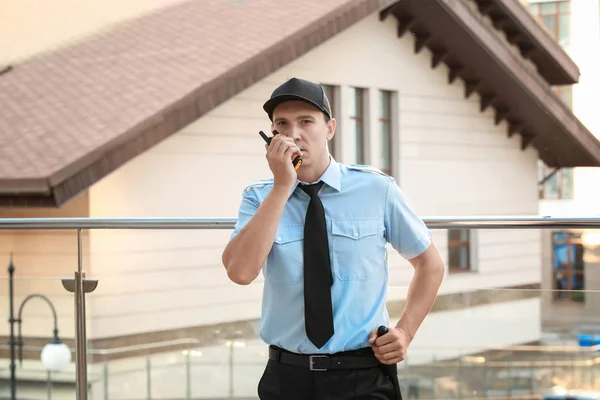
[{"left": 528, "top": 0, "right": 600, "bottom": 340}]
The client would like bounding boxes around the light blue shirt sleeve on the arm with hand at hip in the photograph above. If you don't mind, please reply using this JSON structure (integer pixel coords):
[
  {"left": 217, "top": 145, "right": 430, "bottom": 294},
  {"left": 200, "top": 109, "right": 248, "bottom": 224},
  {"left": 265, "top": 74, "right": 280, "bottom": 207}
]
[{"left": 384, "top": 179, "right": 431, "bottom": 260}]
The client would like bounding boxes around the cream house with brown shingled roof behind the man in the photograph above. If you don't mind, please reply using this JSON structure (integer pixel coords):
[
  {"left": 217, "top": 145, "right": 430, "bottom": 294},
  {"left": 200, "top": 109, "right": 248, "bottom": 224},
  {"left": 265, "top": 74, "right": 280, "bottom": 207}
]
[{"left": 0, "top": 0, "right": 600, "bottom": 393}]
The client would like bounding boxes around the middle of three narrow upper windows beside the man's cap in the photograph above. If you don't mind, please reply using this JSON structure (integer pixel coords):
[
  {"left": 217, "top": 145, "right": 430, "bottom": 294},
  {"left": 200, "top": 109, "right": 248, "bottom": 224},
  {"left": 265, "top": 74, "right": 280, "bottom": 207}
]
[{"left": 344, "top": 87, "right": 365, "bottom": 164}]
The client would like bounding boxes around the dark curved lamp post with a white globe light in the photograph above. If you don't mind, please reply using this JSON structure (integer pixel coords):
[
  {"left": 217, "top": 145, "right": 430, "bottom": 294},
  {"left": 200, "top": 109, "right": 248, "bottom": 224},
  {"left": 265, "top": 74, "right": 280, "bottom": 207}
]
[{"left": 8, "top": 253, "right": 71, "bottom": 400}]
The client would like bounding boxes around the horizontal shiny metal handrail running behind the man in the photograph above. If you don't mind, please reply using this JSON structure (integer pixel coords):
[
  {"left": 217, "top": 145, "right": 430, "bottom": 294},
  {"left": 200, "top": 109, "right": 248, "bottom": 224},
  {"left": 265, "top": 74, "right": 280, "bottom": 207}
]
[{"left": 0, "top": 216, "right": 600, "bottom": 230}]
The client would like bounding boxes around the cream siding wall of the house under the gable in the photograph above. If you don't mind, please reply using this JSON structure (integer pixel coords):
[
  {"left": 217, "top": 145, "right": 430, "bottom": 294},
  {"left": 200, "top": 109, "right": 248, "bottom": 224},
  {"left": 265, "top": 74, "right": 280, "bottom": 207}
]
[{"left": 85, "top": 11, "right": 540, "bottom": 337}]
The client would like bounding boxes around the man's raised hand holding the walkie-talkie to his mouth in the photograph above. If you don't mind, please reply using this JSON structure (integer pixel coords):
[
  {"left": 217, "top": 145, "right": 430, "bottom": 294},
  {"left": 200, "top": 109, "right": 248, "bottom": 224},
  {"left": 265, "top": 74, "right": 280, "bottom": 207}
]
[{"left": 265, "top": 134, "right": 302, "bottom": 188}]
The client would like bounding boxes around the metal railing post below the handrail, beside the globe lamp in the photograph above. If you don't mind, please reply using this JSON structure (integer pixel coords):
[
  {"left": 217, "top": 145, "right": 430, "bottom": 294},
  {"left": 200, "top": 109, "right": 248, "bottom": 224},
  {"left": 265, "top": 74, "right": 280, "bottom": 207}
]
[{"left": 62, "top": 228, "right": 98, "bottom": 400}]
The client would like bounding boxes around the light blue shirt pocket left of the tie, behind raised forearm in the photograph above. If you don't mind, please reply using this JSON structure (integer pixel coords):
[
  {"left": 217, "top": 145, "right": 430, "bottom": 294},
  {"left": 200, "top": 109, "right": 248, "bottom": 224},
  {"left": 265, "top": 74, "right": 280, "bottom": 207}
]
[{"left": 266, "top": 224, "right": 304, "bottom": 285}]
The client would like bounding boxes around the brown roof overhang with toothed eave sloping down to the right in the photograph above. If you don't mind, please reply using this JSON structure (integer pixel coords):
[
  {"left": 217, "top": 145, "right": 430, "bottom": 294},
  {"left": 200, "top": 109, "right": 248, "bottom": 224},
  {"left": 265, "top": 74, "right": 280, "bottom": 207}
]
[{"left": 381, "top": 0, "right": 600, "bottom": 168}]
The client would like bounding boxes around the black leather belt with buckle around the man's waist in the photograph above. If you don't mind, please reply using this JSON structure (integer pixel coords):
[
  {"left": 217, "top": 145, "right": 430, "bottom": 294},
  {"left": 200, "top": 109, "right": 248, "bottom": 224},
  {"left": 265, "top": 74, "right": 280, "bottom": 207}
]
[{"left": 269, "top": 346, "right": 381, "bottom": 371}]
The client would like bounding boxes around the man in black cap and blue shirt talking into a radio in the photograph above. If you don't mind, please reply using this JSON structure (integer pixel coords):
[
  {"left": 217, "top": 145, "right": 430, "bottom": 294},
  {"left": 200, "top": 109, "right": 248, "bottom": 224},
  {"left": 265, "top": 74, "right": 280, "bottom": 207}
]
[{"left": 222, "top": 78, "right": 444, "bottom": 400}]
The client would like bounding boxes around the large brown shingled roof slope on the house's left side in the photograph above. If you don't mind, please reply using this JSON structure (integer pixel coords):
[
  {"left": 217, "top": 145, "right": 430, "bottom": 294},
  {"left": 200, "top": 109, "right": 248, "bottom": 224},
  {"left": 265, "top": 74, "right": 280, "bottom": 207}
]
[{"left": 0, "top": 0, "right": 600, "bottom": 206}]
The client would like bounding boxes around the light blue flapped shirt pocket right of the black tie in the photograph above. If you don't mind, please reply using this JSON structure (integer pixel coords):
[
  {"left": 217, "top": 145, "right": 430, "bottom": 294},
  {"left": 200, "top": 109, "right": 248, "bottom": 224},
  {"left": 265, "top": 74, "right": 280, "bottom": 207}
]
[{"left": 331, "top": 218, "right": 385, "bottom": 281}]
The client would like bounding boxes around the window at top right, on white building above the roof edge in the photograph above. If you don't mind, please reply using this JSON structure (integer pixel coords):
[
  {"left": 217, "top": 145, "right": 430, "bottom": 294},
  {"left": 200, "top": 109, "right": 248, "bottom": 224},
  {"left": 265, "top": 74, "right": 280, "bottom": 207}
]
[{"left": 529, "top": 0, "right": 571, "bottom": 46}]
